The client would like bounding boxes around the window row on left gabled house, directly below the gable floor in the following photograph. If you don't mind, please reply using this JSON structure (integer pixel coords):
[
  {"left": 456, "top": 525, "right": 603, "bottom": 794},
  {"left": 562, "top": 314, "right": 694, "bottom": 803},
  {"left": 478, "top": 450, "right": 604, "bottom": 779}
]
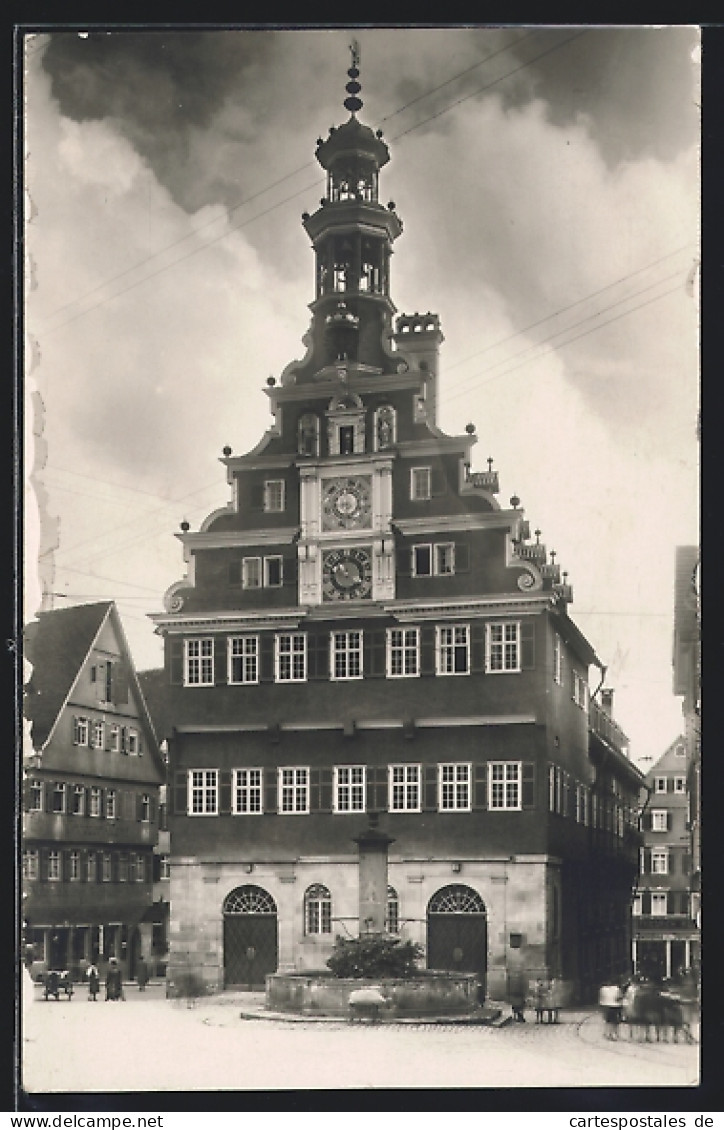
[{"left": 25, "top": 779, "right": 157, "bottom": 824}]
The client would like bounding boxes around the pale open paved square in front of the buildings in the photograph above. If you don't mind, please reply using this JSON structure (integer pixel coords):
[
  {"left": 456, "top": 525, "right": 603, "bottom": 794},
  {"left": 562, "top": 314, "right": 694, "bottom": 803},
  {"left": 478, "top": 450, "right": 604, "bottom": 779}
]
[{"left": 23, "top": 984, "right": 699, "bottom": 1093}]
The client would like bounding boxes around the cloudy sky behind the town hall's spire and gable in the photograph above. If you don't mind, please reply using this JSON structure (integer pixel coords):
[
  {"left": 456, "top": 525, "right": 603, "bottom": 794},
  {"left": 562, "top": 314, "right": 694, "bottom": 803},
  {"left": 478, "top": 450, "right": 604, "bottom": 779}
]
[{"left": 24, "top": 25, "right": 700, "bottom": 770}]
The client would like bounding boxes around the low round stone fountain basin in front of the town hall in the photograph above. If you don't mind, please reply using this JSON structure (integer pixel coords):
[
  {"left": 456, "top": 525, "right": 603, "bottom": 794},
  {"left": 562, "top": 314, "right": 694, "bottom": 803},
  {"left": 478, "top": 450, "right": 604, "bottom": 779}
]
[{"left": 265, "top": 970, "right": 480, "bottom": 1019}]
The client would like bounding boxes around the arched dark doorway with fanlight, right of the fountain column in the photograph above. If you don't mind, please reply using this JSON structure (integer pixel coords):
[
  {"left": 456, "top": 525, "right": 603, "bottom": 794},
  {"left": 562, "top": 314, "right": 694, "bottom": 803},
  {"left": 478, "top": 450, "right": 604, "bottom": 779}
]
[{"left": 427, "top": 883, "right": 488, "bottom": 1000}]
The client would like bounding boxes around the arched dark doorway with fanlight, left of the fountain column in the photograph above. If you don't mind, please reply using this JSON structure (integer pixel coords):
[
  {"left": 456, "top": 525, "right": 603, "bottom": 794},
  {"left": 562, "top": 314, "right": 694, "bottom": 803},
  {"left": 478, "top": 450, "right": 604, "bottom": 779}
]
[{"left": 223, "top": 884, "right": 278, "bottom": 991}]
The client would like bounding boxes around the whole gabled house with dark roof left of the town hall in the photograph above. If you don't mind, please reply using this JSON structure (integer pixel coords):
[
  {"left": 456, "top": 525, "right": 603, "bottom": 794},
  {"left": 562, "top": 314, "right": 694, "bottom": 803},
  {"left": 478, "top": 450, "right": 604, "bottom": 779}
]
[{"left": 23, "top": 601, "right": 165, "bottom": 976}]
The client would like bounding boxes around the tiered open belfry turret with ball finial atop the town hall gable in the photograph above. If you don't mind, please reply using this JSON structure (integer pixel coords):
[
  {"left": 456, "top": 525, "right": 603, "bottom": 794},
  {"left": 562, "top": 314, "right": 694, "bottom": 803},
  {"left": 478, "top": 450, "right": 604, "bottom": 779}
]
[{"left": 303, "top": 46, "right": 402, "bottom": 366}]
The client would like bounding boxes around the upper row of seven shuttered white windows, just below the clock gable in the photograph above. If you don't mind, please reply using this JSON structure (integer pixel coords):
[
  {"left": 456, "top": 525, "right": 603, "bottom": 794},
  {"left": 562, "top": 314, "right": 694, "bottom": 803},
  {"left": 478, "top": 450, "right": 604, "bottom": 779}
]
[{"left": 171, "top": 620, "right": 542, "bottom": 687}]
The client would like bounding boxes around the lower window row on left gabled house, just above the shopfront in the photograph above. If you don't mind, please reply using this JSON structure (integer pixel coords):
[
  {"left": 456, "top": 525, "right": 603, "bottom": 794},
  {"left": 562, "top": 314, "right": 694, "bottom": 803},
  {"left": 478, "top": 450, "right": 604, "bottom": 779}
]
[{"left": 23, "top": 848, "right": 152, "bottom": 883}]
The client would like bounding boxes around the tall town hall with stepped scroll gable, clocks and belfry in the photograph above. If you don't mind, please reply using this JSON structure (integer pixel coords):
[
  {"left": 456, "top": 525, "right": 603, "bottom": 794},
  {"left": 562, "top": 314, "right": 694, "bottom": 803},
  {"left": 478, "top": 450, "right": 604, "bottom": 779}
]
[{"left": 154, "top": 61, "right": 640, "bottom": 998}]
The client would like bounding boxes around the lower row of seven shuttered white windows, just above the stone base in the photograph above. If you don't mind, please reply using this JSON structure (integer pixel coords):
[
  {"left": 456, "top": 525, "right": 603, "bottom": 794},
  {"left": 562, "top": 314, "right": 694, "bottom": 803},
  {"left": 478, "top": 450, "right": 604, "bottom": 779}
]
[{"left": 175, "top": 762, "right": 535, "bottom": 816}]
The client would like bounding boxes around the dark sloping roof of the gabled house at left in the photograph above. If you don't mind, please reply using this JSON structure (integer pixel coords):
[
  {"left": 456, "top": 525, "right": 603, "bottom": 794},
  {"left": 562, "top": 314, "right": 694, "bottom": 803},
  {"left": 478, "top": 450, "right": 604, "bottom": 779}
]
[{"left": 24, "top": 600, "right": 113, "bottom": 749}]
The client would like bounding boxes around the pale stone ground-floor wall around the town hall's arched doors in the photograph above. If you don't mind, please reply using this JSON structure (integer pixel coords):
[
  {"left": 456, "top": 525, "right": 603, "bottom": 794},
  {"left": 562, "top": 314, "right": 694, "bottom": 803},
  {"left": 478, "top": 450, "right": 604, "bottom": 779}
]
[{"left": 168, "top": 854, "right": 560, "bottom": 1001}]
